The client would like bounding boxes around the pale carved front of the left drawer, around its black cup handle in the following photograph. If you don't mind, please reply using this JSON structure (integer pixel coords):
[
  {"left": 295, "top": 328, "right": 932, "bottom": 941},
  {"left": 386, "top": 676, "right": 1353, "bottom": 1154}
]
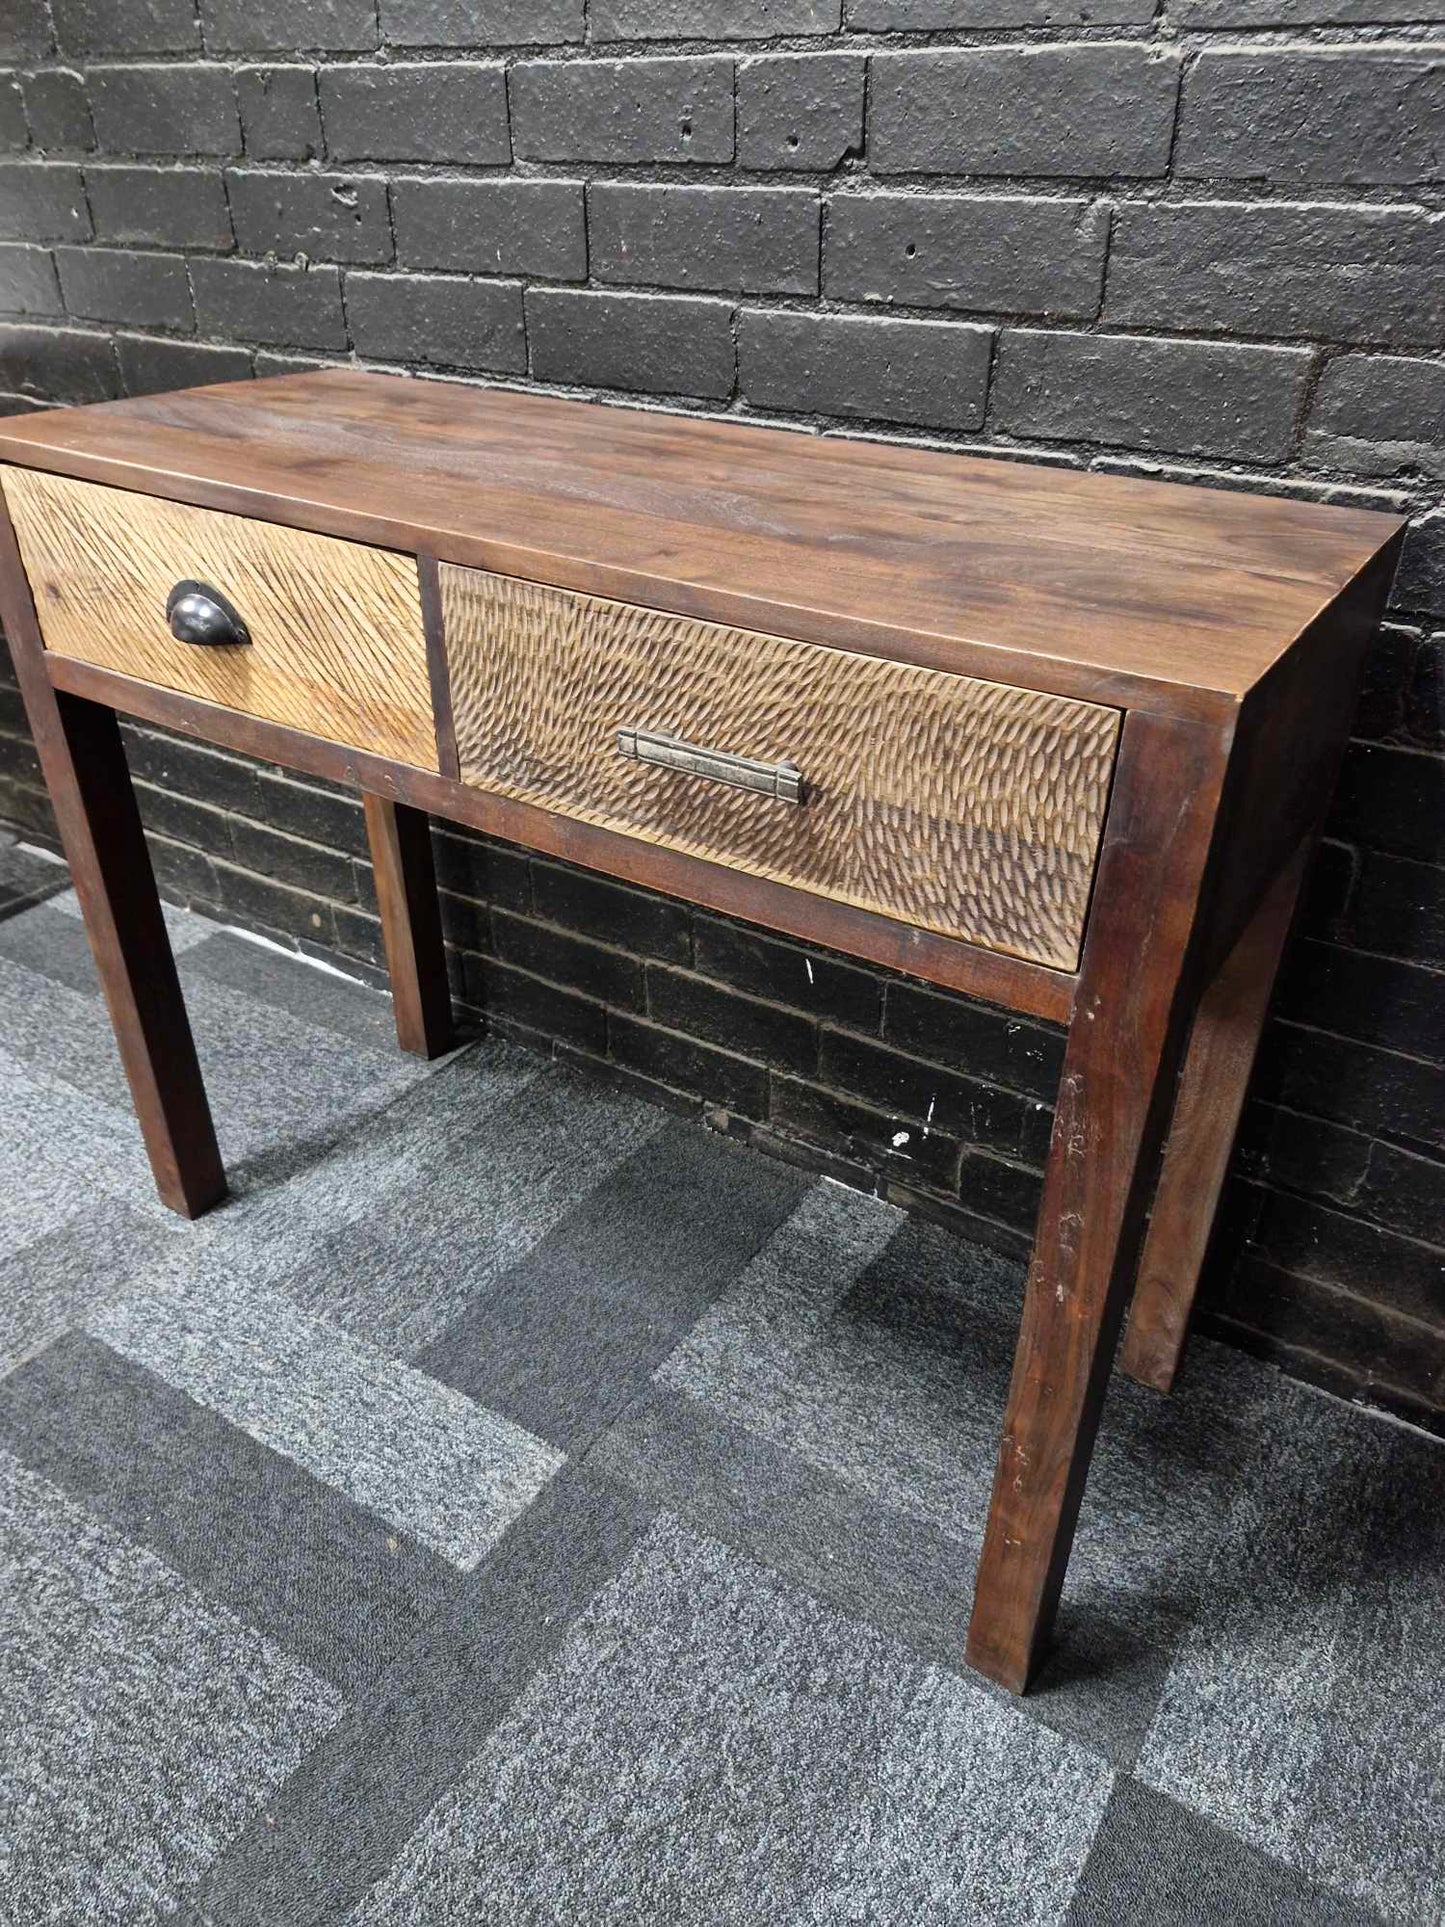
[{"left": 4, "top": 468, "right": 437, "bottom": 769}]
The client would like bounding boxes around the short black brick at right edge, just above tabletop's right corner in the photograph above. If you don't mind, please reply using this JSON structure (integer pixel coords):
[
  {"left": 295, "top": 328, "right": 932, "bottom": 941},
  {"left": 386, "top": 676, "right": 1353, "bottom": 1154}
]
[{"left": 1304, "top": 355, "right": 1445, "bottom": 476}]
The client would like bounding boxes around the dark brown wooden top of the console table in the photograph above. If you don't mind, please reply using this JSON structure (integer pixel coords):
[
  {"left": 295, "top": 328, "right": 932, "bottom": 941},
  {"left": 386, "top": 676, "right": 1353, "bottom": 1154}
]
[{"left": 0, "top": 368, "right": 1401, "bottom": 717}]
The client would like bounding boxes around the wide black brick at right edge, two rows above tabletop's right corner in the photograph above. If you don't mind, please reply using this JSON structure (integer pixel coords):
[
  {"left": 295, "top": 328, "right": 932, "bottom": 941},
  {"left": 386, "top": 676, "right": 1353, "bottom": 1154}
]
[{"left": 1104, "top": 200, "right": 1445, "bottom": 349}]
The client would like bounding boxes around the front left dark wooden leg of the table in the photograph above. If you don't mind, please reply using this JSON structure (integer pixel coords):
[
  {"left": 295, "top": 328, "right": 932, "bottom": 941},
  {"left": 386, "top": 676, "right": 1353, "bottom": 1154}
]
[{"left": 0, "top": 503, "right": 225, "bottom": 1218}]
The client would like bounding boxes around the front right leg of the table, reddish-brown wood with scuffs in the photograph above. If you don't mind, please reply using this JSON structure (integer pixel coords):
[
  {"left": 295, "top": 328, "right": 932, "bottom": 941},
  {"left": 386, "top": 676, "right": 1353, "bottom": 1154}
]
[{"left": 967, "top": 715, "right": 1227, "bottom": 1692}]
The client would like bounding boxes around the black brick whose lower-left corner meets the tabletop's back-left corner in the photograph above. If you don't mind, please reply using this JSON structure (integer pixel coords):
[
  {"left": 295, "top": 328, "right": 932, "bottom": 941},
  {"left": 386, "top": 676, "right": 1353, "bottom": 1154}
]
[{"left": 347, "top": 274, "right": 526, "bottom": 374}]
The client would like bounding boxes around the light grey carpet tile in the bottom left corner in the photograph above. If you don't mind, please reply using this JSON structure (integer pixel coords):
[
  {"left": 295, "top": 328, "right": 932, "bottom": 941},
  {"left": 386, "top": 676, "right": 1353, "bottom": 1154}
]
[{"left": 0, "top": 1453, "right": 341, "bottom": 1927}]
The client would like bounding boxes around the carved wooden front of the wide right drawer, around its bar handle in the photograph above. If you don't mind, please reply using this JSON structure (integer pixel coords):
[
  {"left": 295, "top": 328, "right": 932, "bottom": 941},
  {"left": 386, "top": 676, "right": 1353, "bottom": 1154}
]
[{"left": 441, "top": 567, "right": 1119, "bottom": 969}]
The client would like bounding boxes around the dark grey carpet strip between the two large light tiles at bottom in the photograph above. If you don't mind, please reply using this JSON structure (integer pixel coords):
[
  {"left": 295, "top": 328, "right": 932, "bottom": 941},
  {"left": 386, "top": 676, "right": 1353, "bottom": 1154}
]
[{"left": 193, "top": 1465, "right": 649, "bottom": 1927}]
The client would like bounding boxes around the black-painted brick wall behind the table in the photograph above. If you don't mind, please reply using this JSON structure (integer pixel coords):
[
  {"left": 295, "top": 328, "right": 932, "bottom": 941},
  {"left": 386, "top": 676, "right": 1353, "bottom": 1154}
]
[{"left": 0, "top": 0, "right": 1445, "bottom": 1424}]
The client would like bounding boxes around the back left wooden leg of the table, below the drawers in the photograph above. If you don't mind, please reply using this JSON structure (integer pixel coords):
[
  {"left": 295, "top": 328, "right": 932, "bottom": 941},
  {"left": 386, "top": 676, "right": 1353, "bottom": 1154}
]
[{"left": 362, "top": 790, "right": 451, "bottom": 1058}]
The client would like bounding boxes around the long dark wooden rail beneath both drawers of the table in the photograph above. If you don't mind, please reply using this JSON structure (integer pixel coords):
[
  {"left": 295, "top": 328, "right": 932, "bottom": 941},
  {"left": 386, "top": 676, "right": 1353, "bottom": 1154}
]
[{"left": 48, "top": 657, "right": 1077, "bottom": 1023}]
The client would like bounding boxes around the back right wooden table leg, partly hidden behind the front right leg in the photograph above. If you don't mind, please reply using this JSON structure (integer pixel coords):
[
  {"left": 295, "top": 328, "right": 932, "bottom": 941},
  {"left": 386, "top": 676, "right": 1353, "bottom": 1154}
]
[{"left": 1119, "top": 848, "right": 1308, "bottom": 1391}]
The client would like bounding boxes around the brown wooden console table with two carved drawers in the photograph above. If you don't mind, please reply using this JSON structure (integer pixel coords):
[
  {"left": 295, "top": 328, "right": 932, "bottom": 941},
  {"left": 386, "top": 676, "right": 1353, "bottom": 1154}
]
[{"left": 0, "top": 370, "right": 1401, "bottom": 1692}]
